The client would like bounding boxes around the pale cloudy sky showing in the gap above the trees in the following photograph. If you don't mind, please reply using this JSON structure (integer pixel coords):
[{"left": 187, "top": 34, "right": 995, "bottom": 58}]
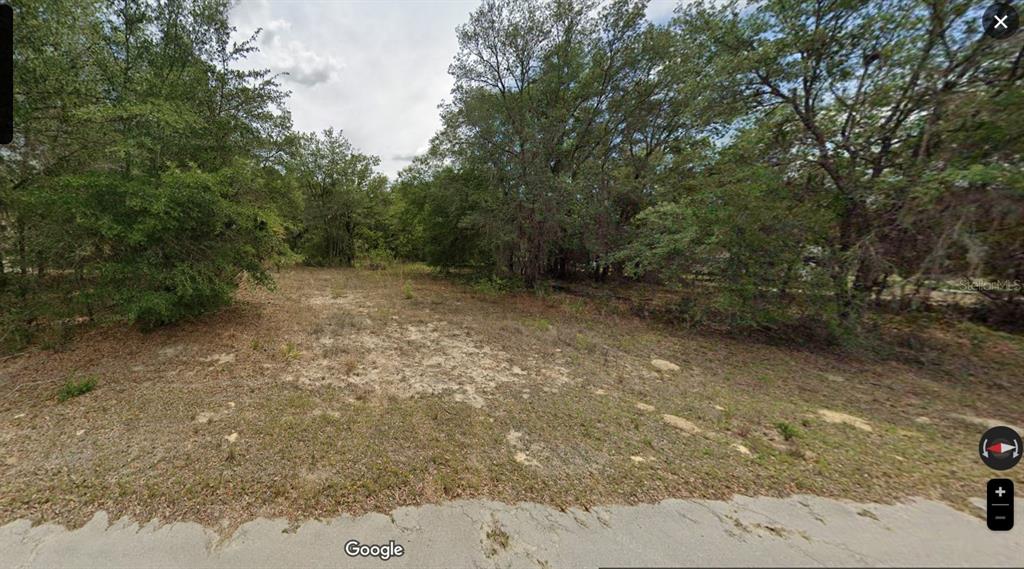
[{"left": 231, "top": 0, "right": 676, "bottom": 179}]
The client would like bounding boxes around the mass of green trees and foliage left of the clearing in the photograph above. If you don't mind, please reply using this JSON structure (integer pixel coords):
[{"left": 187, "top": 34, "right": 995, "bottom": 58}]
[{"left": 0, "top": 0, "right": 296, "bottom": 348}]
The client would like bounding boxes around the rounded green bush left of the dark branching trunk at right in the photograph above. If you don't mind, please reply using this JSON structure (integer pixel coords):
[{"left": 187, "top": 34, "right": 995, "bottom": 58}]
[{"left": 616, "top": 160, "right": 837, "bottom": 331}]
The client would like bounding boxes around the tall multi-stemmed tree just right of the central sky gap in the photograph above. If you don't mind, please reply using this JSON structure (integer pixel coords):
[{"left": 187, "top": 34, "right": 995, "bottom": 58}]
[{"left": 435, "top": 0, "right": 693, "bottom": 283}]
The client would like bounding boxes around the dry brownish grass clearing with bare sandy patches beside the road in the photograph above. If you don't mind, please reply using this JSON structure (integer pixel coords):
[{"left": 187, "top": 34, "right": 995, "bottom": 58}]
[{"left": 0, "top": 267, "right": 1024, "bottom": 527}]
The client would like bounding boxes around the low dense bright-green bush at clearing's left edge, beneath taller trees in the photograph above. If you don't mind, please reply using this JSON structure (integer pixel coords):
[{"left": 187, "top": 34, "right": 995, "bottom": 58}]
[{"left": 62, "top": 169, "right": 283, "bottom": 329}]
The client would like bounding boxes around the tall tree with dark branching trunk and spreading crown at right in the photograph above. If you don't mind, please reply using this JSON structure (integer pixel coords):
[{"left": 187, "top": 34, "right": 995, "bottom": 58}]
[{"left": 674, "top": 0, "right": 1021, "bottom": 326}]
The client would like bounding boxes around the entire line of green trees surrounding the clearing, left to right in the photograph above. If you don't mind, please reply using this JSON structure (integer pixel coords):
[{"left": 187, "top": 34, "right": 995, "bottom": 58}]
[{"left": 0, "top": 0, "right": 1024, "bottom": 347}]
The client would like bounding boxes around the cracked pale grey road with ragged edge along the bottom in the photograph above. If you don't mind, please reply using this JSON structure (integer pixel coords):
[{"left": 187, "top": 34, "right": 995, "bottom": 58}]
[{"left": 0, "top": 496, "right": 1024, "bottom": 569}]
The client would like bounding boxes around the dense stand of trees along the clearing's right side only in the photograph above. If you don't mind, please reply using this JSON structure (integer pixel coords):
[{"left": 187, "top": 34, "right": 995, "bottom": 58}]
[{"left": 395, "top": 0, "right": 1024, "bottom": 332}]
